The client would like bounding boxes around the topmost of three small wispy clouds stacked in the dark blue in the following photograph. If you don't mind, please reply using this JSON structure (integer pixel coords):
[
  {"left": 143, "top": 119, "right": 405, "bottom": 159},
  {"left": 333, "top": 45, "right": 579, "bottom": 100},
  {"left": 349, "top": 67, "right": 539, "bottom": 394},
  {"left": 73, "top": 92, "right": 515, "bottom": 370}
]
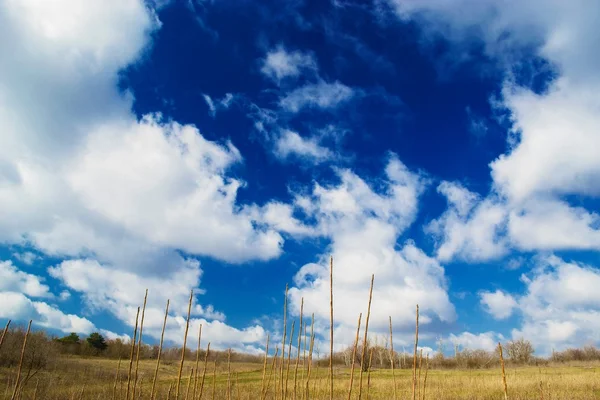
[{"left": 261, "top": 46, "right": 318, "bottom": 83}]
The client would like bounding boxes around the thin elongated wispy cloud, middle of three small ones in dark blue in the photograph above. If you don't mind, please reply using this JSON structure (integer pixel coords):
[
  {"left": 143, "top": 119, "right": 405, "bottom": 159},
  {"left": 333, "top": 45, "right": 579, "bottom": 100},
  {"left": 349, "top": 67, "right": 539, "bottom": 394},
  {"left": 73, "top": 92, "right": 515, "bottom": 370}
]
[{"left": 279, "top": 81, "right": 355, "bottom": 113}]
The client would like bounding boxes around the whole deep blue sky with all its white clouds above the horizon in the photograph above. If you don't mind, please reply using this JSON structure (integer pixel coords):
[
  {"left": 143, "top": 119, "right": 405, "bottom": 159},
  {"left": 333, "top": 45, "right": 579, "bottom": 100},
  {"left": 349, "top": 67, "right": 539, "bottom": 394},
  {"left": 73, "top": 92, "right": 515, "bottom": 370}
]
[{"left": 0, "top": 0, "right": 600, "bottom": 354}]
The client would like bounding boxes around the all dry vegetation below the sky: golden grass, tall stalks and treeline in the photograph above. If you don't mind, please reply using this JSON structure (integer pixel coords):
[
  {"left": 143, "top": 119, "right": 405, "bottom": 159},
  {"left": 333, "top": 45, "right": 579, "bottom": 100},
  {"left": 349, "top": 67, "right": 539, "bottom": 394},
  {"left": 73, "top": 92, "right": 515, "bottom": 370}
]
[{"left": 0, "top": 263, "right": 600, "bottom": 400}]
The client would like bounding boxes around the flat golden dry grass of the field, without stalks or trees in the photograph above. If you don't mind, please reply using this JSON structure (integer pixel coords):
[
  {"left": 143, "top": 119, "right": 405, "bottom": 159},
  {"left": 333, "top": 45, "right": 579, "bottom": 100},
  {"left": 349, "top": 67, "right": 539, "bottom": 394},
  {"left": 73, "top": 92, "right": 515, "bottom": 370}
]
[{"left": 0, "top": 357, "right": 600, "bottom": 400}]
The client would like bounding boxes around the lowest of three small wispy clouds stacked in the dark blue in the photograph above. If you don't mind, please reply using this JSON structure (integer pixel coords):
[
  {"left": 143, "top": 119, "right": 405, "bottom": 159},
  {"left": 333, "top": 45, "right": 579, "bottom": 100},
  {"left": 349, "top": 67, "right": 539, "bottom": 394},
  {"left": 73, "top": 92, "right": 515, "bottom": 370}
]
[{"left": 275, "top": 129, "right": 334, "bottom": 163}]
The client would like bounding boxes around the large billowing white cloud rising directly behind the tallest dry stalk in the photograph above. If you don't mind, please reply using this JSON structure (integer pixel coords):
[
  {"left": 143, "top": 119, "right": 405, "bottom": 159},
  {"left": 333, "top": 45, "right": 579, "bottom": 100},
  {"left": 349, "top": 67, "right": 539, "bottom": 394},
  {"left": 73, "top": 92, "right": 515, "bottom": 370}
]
[{"left": 289, "top": 156, "right": 455, "bottom": 346}]
